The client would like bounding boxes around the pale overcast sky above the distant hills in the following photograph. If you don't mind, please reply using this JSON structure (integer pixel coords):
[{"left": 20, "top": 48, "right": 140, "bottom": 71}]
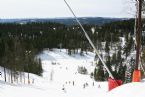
[{"left": 0, "top": 0, "right": 135, "bottom": 18}]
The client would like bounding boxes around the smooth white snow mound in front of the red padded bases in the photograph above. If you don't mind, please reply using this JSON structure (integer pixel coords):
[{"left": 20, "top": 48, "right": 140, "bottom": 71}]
[{"left": 107, "top": 82, "right": 145, "bottom": 97}]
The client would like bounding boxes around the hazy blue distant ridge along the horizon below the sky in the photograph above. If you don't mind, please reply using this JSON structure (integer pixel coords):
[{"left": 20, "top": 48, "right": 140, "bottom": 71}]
[{"left": 0, "top": 17, "right": 127, "bottom": 25}]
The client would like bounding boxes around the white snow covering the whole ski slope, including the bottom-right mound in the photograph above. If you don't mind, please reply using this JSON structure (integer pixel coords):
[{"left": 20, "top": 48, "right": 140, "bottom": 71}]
[{"left": 0, "top": 49, "right": 145, "bottom": 97}]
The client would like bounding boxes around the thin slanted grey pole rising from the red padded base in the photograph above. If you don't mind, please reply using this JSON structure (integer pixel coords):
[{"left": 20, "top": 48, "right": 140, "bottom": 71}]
[{"left": 64, "top": 0, "right": 114, "bottom": 79}]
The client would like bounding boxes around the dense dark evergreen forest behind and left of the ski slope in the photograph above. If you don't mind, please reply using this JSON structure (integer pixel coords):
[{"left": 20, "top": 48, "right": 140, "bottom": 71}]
[{"left": 0, "top": 20, "right": 136, "bottom": 81}]
